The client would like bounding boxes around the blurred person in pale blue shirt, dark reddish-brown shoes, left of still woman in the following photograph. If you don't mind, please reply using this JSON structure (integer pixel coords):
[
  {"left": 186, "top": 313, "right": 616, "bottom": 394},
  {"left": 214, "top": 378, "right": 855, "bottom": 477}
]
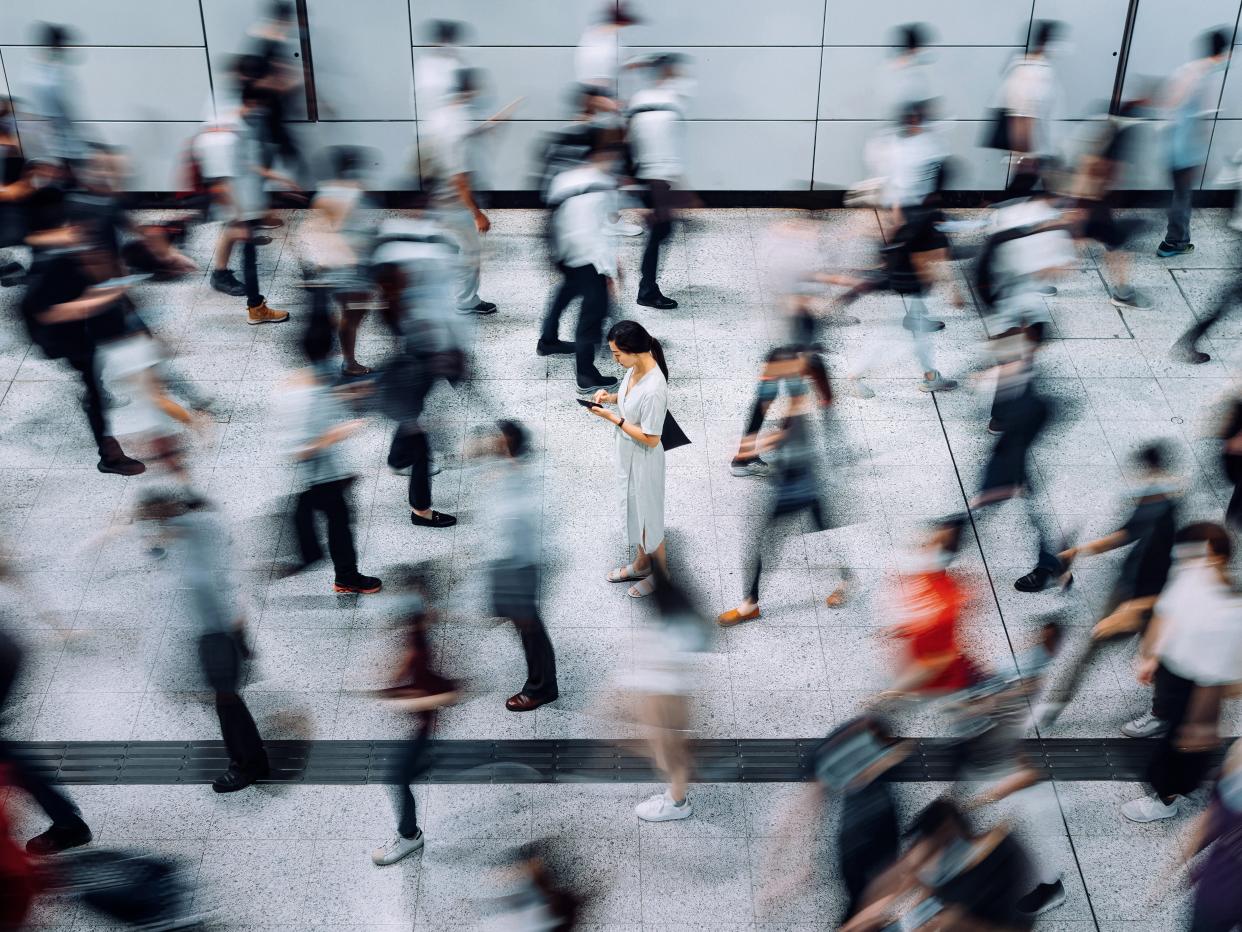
[{"left": 466, "top": 420, "right": 560, "bottom": 712}]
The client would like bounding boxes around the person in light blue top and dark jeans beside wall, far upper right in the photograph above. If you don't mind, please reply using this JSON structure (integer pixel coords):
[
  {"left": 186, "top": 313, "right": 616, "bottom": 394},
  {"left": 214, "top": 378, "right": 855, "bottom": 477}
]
[{"left": 1156, "top": 29, "right": 1231, "bottom": 259}]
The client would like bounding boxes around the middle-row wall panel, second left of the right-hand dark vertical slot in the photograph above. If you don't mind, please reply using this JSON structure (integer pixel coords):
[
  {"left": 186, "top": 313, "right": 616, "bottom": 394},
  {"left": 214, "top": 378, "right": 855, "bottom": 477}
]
[{"left": 820, "top": 46, "right": 1020, "bottom": 119}]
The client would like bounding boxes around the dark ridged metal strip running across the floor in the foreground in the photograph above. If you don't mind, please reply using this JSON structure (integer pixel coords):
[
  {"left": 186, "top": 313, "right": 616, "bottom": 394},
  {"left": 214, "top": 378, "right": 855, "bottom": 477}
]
[{"left": 10, "top": 738, "right": 1222, "bottom": 784}]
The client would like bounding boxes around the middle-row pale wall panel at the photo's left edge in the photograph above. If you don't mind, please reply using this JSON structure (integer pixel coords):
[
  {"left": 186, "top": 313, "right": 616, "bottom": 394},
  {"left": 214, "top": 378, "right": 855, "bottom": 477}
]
[{"left": 2, "top": 46, "right": 210, "bottom": 122}]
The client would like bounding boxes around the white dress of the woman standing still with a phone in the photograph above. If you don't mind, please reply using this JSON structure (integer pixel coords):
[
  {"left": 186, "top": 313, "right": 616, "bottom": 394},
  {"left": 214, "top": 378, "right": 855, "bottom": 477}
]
[{"left": 616, "top": 368, "right": 668, "bottom": 553}]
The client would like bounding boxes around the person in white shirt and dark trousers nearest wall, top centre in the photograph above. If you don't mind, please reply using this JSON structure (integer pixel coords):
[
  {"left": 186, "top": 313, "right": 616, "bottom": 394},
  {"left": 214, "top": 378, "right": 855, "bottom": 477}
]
[{"left": 628, "top": 55, "right": 687, "bottom": 311}]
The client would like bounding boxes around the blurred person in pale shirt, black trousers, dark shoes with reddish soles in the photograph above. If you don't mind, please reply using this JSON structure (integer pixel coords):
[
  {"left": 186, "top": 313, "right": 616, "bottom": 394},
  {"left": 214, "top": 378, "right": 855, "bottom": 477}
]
[{"left": 281, "top": 311, "right": 383, "bottom": 594}]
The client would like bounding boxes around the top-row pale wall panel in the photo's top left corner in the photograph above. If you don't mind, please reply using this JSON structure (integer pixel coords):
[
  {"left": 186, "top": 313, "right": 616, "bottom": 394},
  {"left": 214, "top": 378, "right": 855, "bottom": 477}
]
[{"left": 0, "top": 0, "right": 202, "bottom": 45}]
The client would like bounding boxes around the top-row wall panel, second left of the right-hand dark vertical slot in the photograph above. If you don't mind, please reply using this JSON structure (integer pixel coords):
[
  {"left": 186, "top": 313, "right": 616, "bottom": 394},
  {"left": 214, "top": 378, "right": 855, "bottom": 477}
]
[{"left": 823, "top": 0, "right": 1028, "bottom": 45}]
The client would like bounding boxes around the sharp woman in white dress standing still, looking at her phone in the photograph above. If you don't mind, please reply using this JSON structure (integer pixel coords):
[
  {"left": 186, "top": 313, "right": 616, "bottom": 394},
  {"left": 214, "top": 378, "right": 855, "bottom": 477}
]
[{"left": 587, "top": 321, "right": 668, "bottom": 599}]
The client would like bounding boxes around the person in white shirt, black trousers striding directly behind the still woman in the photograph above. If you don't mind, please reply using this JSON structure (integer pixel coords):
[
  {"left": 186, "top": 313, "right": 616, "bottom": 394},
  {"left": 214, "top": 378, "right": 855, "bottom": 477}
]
[{"left": 535, "top": 129, "right": 617, "bottom": 394}]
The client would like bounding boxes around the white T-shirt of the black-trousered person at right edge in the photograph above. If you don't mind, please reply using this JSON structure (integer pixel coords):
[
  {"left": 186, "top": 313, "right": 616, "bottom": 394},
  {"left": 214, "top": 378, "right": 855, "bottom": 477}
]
[{"left": 1155, "top": 559, "right": 1242, "bottom": 686}]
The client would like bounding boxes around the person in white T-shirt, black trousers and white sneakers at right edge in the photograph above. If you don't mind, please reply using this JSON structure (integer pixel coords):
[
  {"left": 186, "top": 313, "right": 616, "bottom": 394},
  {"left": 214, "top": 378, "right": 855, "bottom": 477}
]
[{"left": 1122, "top": 521, "right": 1242, "bottom": 823}]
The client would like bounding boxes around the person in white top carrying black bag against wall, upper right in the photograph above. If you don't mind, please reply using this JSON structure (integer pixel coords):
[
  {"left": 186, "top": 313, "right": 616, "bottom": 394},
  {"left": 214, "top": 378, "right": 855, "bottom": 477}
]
[{"left": 1001, "top": 20, "right": 1064, "bottom": 194}]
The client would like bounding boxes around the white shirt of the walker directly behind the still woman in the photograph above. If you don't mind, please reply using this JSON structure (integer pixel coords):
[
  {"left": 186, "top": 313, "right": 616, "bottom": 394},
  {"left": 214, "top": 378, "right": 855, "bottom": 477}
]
[{"left": 548, "top": 165, "right": 617, "bottom": 277}]
